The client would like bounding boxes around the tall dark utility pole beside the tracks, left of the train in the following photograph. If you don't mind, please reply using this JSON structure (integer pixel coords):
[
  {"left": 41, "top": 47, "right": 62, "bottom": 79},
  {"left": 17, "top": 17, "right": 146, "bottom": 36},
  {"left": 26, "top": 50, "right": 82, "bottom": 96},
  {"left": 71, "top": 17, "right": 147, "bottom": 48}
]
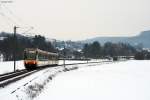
[{"left": 14, "top": 26, "right": 19, "bottom": 72}]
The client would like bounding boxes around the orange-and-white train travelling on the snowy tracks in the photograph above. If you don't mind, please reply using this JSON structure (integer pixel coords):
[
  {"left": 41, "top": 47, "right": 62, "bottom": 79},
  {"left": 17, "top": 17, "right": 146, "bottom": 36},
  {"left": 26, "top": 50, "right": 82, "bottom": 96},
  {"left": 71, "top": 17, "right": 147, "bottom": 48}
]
[{"left": 24, "top": 48, "right": 58, "bottom": 70}]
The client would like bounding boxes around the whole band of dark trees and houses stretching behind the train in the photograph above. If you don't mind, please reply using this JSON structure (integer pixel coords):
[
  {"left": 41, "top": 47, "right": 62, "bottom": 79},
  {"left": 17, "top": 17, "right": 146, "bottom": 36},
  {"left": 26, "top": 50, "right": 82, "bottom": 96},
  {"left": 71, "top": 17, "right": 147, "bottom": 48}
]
[{"left": 0, "top": 32, "right": 150, "bottom": 61}]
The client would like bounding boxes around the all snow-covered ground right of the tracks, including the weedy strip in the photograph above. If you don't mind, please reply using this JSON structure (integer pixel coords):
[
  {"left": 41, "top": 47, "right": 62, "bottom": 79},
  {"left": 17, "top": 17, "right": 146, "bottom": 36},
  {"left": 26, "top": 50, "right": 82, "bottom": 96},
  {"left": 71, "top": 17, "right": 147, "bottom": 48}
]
[{"left": 0, "top": 60, "right": 150, "bottom": 100}]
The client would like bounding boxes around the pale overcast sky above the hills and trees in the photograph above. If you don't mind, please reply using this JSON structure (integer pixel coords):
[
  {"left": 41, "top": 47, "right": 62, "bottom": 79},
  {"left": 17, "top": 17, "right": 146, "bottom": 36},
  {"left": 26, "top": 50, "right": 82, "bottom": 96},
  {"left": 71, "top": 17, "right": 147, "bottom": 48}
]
[{"left": 0, "top": 0, "right": 150, "bottom": 40}]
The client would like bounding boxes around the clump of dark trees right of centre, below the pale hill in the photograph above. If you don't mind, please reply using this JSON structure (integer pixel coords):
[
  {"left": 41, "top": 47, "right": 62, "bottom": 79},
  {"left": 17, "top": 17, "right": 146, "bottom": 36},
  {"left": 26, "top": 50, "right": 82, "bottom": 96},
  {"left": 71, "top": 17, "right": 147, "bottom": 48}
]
[{"left": 82, "top": 41, "right": 136, "bottom": 59}]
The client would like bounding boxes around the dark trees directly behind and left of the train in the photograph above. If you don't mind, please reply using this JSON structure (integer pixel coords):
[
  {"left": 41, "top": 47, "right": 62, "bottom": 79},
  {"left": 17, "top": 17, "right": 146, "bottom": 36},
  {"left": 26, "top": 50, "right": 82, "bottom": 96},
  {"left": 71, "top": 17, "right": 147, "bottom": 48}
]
[{"left": 0, "top": 34, "right": 56, "bottom": 61}]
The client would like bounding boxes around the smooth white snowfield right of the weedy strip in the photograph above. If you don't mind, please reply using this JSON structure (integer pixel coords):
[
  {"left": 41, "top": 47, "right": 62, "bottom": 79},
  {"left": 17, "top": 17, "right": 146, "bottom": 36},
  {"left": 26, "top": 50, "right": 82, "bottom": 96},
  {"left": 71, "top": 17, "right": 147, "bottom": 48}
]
[{"left": 36, "top": 60, "right": 150, "bottom": 100}]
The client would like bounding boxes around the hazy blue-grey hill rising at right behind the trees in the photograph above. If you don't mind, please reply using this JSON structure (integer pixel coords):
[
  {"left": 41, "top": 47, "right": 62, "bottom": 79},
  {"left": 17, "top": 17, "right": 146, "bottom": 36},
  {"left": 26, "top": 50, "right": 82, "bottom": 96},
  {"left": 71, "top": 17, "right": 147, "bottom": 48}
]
[{"left": 82, "top": 30, "right": 150, "bottom": 48}]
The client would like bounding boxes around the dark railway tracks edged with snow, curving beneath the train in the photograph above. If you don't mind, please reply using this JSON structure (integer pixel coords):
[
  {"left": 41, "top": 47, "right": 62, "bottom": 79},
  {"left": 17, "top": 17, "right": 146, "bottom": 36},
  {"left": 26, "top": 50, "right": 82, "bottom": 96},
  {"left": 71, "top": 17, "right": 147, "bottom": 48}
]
[{"left": 0, "top": 61, "right": 110, "bottom": 88}]
